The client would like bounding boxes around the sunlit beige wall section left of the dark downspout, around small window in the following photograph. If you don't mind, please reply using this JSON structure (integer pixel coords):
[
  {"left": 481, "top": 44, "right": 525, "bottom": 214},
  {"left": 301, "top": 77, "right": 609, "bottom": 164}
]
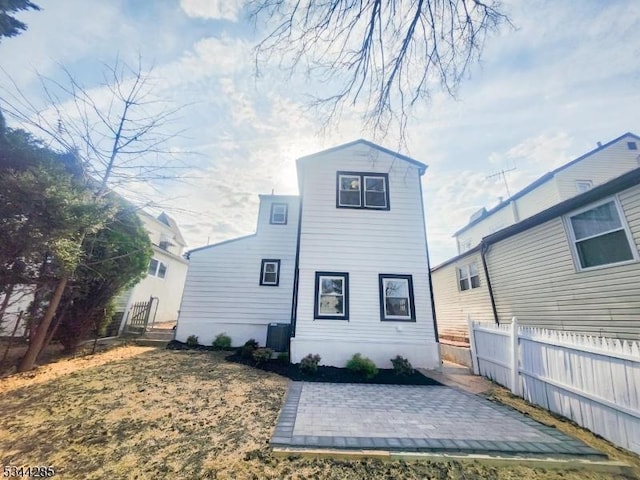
[{"left": 431, "top": 252, "right": 494, "bottom": 342}]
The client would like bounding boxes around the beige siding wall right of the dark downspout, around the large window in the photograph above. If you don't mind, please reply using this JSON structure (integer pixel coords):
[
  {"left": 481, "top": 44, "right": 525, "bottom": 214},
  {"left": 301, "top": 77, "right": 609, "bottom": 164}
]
[{"left": 484, "top": 186, "right": 640, "bottom": 340}]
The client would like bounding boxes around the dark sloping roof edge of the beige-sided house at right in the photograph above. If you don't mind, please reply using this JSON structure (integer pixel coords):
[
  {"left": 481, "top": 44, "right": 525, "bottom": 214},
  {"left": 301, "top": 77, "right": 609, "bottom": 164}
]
[{"left": 431, "top": 168, "right": 640, "bottom": 271}]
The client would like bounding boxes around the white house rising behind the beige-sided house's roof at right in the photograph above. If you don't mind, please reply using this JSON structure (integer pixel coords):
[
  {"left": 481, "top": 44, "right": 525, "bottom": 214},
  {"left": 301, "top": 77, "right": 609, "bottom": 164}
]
[{"left": 453, "top": 133, "right": 640, "bottom": 254}]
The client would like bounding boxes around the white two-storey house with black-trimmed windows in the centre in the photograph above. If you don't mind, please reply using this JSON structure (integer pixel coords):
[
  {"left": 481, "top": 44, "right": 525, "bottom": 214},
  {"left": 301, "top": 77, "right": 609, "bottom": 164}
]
[{"left": 176, "top": 140, "right": 440, "bottom": 368}]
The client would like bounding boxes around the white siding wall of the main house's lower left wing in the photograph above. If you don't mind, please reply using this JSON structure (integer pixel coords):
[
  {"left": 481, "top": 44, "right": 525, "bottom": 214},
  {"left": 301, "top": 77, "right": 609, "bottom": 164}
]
[{"left": 176, "top": 195, "right": 299, "bottom": 346}]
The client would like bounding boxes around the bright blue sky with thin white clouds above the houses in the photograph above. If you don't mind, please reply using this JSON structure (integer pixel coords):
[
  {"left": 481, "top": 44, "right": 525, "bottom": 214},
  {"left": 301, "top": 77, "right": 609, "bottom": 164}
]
[{"left": 0, "top": 0, "right": 640, "bottom": 265}]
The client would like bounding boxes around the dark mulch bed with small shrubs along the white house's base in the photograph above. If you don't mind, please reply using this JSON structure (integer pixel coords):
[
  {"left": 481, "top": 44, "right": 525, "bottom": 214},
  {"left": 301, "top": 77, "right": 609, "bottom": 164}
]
[{"left": 167, "top": 340, "right": 442, "bottom": 386}]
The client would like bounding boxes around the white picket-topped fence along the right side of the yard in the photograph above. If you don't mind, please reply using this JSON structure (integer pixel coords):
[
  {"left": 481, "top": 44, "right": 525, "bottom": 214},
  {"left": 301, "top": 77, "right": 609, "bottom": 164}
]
[{"left": 469, "top": 317, "right": 640, "bottom": 454}]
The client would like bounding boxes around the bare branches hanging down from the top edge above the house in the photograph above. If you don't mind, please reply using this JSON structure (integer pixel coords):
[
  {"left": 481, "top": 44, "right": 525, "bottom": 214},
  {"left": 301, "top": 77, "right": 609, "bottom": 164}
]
[{"left": 250, "top": 0, "right": 511, "bottom": 139}]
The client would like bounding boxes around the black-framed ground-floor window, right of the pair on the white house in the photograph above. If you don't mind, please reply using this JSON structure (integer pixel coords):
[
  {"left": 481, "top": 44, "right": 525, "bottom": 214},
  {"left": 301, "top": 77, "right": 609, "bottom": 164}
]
[{"left": 378, "top": 273, "right": 416, "bottom": 322}]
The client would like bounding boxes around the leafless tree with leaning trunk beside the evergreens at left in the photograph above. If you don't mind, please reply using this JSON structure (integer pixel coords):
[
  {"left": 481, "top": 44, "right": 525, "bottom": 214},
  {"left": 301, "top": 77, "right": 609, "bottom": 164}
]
[{"left": 0, "top": 58, "right": 194, "bottom": 371}]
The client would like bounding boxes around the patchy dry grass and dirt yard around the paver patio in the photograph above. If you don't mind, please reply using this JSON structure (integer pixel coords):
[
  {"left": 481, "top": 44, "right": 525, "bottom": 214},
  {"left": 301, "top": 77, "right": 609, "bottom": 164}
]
[{"left": 0, "top": 346, "right": 640, "bottom": 480}]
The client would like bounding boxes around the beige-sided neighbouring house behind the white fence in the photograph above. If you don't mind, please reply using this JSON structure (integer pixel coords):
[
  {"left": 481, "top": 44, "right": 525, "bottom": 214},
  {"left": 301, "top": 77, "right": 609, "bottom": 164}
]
[{"left": 432, "top": 168, "right": 640, "bottom": 343}]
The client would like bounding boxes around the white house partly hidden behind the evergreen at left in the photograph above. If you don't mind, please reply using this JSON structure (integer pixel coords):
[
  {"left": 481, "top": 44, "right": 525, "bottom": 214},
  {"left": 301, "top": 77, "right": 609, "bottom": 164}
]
[{"left": 114, "top": 211, "right": 188, "bottom": 333}]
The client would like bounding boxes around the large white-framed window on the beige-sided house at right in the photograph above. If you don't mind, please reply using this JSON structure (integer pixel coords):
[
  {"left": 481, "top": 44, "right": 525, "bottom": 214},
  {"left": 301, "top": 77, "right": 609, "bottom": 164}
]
[{"left": 566, "top": 199, "right": 637, "bottom": 270}]
